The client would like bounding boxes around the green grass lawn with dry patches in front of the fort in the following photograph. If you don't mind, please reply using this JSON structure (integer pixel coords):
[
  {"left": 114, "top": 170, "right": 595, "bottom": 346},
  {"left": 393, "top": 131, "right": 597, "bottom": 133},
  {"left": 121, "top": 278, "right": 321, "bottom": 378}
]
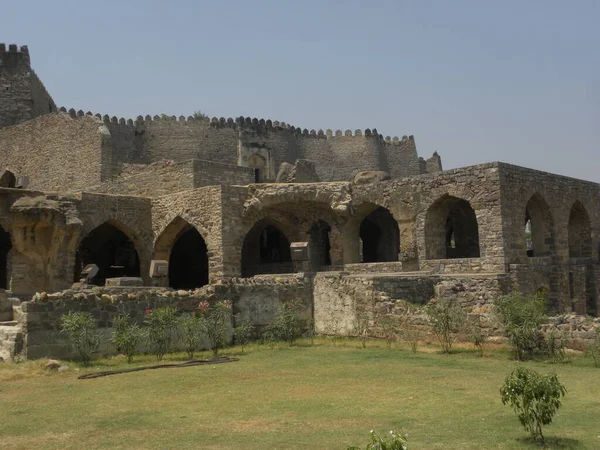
[{"left": 0, "top": 342, "right": 600, "bottom": 450}]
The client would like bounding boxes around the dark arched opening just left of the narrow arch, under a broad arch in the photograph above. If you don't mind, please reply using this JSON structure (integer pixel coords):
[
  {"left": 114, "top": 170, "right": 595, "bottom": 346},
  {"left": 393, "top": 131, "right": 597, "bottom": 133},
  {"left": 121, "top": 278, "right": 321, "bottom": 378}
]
[{"left": 242, "top": 220, "right": 294, "bottom": 277}]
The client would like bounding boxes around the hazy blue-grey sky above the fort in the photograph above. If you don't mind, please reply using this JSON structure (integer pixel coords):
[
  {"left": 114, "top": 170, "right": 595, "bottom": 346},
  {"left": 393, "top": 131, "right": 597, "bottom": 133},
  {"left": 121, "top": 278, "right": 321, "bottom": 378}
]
[{"left": 0, "top": 0, "right": 600, "bottom": 182}]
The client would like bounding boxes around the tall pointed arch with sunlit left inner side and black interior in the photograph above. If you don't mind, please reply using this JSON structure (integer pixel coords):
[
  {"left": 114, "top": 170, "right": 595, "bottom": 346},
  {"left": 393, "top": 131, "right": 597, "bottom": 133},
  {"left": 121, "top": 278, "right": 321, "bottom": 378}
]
[{"left": 154, "top": 216, "right": 209, "bottom": 290}]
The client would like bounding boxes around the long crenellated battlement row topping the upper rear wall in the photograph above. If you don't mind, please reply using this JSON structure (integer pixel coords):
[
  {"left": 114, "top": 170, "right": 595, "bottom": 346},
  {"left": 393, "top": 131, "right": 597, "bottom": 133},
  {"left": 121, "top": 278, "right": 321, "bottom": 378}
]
[{"left": 60, "top": 106, "right": 414, "bottom": 145}]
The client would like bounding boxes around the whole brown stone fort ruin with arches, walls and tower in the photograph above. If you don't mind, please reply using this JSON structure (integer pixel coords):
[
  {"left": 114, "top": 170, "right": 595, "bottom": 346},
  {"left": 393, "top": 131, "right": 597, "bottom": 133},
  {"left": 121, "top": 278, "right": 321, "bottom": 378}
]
[{"left": 0, "top": 44, "right": 600, "bottom": 358}]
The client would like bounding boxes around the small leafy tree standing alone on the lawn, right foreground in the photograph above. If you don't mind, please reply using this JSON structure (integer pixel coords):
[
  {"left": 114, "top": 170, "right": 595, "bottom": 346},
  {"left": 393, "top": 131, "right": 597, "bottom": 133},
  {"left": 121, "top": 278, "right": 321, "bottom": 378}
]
[{"left": 500, "top": 367, "right": 567, "bottom": 445}]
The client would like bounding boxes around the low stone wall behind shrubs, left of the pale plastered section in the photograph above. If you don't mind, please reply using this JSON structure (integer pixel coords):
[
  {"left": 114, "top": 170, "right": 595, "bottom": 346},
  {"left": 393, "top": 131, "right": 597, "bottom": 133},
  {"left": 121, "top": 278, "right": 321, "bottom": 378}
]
[{"left": 18, "top": 275, "right": 312, "bottom": 359}]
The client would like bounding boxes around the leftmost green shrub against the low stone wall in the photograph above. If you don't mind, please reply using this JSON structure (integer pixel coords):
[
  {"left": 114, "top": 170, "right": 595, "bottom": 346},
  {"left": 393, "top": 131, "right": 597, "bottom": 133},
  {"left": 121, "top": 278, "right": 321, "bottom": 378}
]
[{"left": 60, "top": 312, "right": 100, "bottom": 366}]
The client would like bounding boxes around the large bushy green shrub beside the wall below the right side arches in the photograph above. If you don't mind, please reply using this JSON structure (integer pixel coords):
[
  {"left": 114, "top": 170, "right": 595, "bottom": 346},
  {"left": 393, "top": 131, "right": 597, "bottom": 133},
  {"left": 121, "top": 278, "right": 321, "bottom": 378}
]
[{"left": 495, "top": 291, "right": 547, "bottom": 361}]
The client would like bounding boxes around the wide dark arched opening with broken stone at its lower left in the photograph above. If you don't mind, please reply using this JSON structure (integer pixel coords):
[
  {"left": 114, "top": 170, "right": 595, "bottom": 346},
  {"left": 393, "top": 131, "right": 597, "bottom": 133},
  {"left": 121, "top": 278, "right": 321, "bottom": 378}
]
[{"left": 75, "top": 222, "right": 140, "bottom": 286}]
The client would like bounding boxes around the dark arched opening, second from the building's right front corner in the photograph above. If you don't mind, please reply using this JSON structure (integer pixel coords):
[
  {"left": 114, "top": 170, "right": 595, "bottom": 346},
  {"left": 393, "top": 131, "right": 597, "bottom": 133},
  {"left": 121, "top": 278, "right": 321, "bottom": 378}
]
[{"left": 359, "top": 207, "right": 400, "bottom": 263}]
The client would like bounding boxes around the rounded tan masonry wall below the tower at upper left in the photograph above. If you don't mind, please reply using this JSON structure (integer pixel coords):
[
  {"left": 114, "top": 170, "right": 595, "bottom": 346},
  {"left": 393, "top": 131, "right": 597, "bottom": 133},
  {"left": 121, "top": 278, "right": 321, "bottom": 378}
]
[{"left": 0, "top": 113, "right": 112, "bottom": 191}]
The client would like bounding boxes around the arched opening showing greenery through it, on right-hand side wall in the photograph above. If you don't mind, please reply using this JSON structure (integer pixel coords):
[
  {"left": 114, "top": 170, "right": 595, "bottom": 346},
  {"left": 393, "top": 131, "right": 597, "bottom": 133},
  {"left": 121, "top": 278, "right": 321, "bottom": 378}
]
[{"left": 525, "top": 194, "right": 554, "bottom": 257}]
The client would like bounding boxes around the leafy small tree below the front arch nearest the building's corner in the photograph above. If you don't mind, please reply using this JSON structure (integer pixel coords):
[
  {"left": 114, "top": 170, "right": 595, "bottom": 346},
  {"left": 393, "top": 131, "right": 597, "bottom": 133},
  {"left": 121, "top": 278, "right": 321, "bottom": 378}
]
[{"left": 425, "top": 299, "right": 466, "bottom": 353}]
